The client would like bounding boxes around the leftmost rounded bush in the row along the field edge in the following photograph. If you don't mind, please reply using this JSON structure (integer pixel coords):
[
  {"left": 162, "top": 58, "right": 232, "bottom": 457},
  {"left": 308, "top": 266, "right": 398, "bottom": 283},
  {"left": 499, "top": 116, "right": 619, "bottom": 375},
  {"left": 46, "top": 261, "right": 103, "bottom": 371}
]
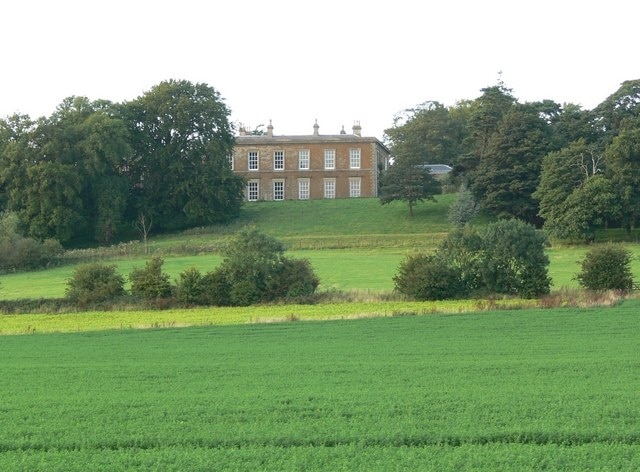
[{"left": 66, "top": 262, "right": 125, "bottom": 305}]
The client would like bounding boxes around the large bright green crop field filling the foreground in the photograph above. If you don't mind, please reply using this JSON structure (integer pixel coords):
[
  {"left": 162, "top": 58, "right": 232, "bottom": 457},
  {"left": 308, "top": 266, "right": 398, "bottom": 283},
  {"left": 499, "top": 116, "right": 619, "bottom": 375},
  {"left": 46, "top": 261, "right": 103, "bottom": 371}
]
[{"left": 0, "top": 300, "right": 640, "bottom": 471}]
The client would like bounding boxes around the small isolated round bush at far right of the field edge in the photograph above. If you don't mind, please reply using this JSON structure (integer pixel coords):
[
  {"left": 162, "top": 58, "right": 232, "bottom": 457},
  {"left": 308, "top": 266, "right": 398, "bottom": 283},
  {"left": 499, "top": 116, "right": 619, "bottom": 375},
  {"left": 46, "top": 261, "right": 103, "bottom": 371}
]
[{"left": 575, "top": 245, "right": 633, "bottom": 291}]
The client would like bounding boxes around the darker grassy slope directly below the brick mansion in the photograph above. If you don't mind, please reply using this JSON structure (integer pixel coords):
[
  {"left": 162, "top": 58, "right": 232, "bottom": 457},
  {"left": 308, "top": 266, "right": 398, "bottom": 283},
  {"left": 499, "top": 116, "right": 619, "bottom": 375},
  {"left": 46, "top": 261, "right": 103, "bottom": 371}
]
[{"left": 145, "top": 194, "right": 456, "bottom": 250}]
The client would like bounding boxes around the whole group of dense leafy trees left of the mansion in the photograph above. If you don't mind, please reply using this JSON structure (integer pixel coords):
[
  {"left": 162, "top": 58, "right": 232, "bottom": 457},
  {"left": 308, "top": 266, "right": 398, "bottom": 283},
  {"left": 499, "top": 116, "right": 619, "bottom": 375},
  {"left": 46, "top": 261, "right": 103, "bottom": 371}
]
[{"left": 0, "top": 80, "right": 243, "bottom": 245}]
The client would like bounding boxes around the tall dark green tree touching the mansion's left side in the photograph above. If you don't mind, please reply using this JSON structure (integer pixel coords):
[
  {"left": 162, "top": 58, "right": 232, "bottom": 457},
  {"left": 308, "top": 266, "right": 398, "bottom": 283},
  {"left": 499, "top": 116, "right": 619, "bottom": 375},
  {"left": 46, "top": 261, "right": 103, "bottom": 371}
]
[{"left": 123, "top": 80, "right": 244, "bottom": 229}]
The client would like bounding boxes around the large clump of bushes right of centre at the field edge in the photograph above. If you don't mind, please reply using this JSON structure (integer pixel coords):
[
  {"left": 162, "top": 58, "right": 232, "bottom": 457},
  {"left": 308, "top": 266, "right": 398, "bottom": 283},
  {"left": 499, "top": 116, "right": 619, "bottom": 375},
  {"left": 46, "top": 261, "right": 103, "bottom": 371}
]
[{"left": 394, "top": 220, "right": 551, "bottom": 300}]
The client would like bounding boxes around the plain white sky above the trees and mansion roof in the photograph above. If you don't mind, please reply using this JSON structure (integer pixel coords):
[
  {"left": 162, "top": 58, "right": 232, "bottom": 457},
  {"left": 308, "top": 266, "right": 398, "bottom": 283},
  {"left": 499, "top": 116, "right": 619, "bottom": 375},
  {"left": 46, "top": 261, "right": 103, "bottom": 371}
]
[{"left": 0, "top": 0, "right": 640, "bottom": 139}]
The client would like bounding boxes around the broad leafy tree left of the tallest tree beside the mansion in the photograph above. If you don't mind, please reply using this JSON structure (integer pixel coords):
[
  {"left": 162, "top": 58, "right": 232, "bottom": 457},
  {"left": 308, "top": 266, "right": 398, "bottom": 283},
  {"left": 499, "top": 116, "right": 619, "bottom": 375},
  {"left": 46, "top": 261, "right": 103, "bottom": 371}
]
[{"left": 5, "top": 97, "right": 130, "bottom": 242}]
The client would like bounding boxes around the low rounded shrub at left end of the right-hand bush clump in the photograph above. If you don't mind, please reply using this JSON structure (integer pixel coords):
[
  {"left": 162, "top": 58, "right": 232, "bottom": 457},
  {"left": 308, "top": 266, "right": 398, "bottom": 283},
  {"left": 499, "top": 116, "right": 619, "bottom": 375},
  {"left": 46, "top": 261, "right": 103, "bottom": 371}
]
[{"left": 393, "top": 254, "right": 466, "bottom": 300}]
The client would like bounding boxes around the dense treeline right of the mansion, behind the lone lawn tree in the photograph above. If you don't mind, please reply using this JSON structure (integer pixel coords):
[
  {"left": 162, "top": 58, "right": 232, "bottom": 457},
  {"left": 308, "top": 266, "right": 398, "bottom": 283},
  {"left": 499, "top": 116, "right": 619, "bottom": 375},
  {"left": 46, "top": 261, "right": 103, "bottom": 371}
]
[{"left": 386, "top": 80, "right": 640, "bottom": 241}]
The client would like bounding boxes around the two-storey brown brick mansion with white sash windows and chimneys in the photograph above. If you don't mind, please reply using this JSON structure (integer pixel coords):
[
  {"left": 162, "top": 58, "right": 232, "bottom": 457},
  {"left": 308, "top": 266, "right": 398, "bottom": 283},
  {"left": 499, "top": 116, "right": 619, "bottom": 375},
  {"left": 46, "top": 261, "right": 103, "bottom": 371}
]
[{"left": 232, "top": 122, "right": 389, "bottom": 201}]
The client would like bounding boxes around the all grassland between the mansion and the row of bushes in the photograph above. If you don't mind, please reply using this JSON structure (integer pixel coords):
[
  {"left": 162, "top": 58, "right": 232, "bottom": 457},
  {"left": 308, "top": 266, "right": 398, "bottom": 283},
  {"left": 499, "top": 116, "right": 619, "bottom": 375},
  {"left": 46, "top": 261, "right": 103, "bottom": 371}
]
[{"left": 5, "top": 194, "right": 640, "bottom": 300}]
